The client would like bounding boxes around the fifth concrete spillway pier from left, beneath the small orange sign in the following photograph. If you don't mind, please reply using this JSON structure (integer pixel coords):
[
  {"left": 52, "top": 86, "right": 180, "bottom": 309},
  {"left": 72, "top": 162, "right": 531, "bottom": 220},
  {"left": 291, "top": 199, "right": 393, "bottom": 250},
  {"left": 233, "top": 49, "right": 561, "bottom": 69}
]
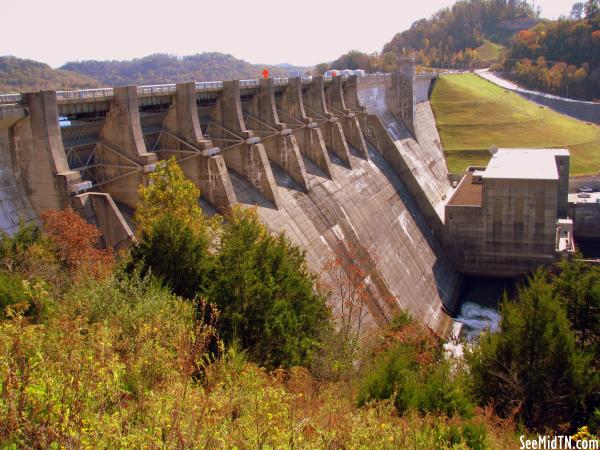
[{"left": 250, "top": 78, "right": 309, "bottom": 191}]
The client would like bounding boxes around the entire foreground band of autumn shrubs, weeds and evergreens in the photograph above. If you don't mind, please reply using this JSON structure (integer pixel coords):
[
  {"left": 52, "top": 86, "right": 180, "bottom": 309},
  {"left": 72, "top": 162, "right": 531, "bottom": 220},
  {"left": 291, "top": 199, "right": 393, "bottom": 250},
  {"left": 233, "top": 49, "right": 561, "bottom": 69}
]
[{"left": 0, "top": 160, "right": 600, "bottom": 449}]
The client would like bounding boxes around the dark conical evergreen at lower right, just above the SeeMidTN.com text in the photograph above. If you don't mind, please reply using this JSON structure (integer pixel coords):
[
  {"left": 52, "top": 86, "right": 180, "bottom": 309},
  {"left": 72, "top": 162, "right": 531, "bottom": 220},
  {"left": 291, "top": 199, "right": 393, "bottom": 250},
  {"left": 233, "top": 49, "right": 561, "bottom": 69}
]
[{"left": 471, "top": 269, "right": 590, "bottom": 430}]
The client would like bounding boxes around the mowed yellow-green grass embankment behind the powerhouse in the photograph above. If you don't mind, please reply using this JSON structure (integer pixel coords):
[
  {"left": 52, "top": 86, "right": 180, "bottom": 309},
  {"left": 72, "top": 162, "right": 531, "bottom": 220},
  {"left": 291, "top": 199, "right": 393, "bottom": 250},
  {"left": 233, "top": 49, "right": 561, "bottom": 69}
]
[{"left": 431, "top": 74, "right": 600, "bottom": 175}]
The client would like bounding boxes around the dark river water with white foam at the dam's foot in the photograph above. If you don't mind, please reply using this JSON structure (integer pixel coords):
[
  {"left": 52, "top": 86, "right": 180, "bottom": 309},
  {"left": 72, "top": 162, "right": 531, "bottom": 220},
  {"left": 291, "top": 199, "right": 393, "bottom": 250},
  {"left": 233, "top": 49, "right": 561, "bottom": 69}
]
[{"left": 455, "top": 277, "right": 517, "bottom": 341}]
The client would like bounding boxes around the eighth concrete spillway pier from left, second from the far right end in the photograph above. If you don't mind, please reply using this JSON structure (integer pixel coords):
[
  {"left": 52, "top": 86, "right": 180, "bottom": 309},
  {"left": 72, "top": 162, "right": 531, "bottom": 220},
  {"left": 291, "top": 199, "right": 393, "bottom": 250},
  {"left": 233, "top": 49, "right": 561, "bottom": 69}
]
[{"left": 325, "top": 77, "right": 369, "bottom": 159}]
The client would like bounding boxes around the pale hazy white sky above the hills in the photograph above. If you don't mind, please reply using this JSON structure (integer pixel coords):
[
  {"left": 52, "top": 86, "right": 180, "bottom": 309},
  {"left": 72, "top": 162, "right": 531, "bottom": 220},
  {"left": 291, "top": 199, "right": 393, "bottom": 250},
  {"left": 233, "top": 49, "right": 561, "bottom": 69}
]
[{"left": 0, "top": 0, "right": 575, "bottom": 67}]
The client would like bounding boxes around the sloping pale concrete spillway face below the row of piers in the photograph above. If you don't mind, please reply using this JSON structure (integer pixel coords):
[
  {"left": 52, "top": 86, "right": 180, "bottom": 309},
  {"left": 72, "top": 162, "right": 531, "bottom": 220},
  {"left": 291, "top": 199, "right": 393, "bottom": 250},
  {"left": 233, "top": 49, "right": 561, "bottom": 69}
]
[{"left": 232, "top": 147, "right": 459, "bottom": 334}]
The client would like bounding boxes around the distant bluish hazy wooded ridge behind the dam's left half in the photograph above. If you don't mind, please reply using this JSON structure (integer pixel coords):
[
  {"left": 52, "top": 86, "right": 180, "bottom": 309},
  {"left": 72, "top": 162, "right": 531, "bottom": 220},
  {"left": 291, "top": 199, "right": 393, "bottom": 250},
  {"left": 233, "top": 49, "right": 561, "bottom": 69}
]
[{"left": 61, "top": 53, "right": 308, "bottom": 85}]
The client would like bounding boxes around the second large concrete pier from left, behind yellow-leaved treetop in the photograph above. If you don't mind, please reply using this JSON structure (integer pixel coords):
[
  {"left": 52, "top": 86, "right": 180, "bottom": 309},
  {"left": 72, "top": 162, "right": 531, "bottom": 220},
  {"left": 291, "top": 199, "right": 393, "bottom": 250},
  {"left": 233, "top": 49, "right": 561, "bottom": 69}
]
[{"left": 97, "top": 86, "right": 156, "bottom": 209}]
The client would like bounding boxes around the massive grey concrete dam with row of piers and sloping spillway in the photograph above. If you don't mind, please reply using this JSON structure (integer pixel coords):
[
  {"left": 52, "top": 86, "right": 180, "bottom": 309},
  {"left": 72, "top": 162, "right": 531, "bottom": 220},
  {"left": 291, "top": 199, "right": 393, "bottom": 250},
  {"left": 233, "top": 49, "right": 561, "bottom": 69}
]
[{"left": 0, "top": 61, "right": 468, "bottom": 334}]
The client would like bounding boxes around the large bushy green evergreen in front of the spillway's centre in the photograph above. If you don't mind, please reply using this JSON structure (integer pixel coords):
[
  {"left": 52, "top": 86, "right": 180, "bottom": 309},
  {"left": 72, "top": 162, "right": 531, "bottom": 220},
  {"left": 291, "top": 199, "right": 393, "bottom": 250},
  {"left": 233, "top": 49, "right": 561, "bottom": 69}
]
[{"left": 210, "top": 207, "right": 329, "bottom": 368}]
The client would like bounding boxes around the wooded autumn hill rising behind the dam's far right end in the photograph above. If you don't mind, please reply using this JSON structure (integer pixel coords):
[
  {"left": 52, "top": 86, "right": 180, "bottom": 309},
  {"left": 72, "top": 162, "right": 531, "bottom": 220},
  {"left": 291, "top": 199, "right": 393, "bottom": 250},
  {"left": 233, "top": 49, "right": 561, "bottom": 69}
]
[{"left": 315, "top": 0, "right": 538, "bottom": 74}]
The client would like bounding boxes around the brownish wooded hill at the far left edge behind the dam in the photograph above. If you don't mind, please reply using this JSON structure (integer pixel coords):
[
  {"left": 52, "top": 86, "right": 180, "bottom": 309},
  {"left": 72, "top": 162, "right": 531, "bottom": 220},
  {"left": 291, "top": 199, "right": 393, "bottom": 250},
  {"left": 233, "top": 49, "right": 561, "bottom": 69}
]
[{"left": 0, "top": 56, "right": 100, "bottom": 92}]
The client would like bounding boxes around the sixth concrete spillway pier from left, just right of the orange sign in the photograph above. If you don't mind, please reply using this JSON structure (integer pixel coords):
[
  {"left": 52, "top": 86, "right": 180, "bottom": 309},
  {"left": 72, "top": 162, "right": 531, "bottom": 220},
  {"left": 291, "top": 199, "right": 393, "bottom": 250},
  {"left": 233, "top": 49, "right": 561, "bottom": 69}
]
[{"left": 277, "top": 77, "right": 333, "bottom": 179}]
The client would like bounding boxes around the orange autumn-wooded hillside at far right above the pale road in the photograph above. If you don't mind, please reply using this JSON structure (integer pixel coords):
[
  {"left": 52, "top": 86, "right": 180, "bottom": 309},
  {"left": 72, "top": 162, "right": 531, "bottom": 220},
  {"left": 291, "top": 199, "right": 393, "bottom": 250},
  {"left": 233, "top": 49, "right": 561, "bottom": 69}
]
[{"left": 505, "top": 0, "right": 600, "bottom": 100}]
